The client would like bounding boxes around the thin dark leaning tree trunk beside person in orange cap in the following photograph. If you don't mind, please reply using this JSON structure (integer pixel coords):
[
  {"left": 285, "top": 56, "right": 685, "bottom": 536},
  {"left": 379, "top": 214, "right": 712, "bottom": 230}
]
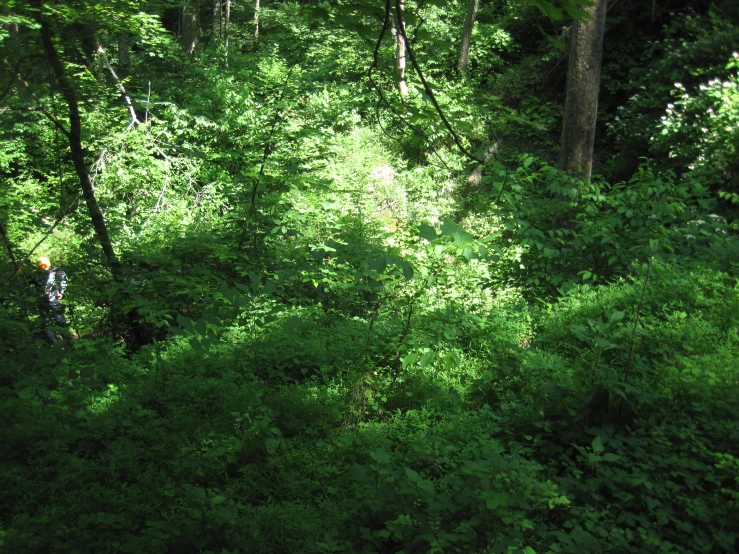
[{"left": 31, "top": 0, "right": 121, "bottom": 280}]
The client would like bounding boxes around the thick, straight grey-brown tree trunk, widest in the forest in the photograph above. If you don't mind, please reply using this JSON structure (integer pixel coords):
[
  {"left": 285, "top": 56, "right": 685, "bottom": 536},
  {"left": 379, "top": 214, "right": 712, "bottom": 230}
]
[{"left": 559, "top": 0, "right": 606, "bottom": 180}]
